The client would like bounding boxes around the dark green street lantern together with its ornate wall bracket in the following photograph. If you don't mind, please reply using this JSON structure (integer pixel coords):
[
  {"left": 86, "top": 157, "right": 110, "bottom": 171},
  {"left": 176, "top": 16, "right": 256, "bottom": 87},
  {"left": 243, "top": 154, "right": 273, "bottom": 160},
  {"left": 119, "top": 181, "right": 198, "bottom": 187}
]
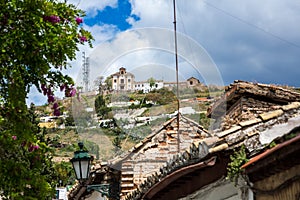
[{"left": 70, "top": 142, "right": 119, "bottom": 199}]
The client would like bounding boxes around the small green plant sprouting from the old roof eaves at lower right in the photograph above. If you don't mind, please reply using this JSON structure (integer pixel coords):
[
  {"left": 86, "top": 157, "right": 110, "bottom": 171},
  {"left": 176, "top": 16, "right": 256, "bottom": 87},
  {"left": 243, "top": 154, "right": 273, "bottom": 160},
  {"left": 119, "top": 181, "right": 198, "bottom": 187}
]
[{"left": 227, "top": 145, "right": 249, "bottom": 184}]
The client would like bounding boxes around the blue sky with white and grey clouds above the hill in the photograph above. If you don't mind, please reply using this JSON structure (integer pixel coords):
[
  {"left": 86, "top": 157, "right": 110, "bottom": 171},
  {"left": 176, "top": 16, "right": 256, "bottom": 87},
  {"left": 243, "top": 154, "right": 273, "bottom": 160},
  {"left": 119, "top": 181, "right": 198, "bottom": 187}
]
[{"left": 30, "top": 0, "right": 300, "bottom": 105}]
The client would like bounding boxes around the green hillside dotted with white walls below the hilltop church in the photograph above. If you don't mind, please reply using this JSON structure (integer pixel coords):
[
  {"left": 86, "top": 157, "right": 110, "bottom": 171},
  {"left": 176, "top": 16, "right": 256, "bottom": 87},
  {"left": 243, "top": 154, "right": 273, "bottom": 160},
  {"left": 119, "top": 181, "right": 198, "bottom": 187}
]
[{"left": 36, "top": 86, "right": 221, "bottom": 162}]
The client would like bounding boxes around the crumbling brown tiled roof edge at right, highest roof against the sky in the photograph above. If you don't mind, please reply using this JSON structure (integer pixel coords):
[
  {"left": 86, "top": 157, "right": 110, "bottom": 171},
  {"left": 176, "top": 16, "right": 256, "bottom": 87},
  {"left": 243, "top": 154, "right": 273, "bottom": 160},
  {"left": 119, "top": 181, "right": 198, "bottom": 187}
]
[{"left": 207, "top": 80, "right": 300, "bottom": 118}]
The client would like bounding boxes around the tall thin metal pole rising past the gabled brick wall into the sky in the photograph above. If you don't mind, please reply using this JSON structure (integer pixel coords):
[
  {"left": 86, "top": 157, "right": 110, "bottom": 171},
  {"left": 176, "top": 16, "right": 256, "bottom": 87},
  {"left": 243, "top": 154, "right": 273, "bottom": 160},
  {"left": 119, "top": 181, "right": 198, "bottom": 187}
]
[{"left": 173, "top": 0, "right": 180, "bottom": 153}]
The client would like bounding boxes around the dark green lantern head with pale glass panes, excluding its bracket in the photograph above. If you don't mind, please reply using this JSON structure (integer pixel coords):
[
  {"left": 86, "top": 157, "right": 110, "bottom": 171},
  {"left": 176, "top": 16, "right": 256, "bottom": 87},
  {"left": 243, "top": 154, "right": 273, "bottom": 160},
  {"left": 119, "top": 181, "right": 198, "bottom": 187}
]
[{"left": 71, "top": 142, "right": 92, "bottom": 182}]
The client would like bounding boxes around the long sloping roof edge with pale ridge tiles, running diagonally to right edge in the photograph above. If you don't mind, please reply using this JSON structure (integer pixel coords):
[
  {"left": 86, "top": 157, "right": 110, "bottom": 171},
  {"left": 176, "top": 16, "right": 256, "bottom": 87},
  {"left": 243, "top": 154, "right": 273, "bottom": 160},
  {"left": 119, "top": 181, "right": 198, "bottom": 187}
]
[{"left": 126, "top": 102, "right": 300, "bottom": 200}]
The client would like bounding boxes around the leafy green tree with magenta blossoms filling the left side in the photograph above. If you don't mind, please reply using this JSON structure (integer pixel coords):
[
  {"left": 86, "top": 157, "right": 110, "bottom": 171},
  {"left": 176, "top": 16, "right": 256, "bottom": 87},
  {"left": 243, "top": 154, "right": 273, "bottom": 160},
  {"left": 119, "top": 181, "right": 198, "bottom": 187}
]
[{"left": 0, "top": 0, "right": 92, "bottom": 199}]
